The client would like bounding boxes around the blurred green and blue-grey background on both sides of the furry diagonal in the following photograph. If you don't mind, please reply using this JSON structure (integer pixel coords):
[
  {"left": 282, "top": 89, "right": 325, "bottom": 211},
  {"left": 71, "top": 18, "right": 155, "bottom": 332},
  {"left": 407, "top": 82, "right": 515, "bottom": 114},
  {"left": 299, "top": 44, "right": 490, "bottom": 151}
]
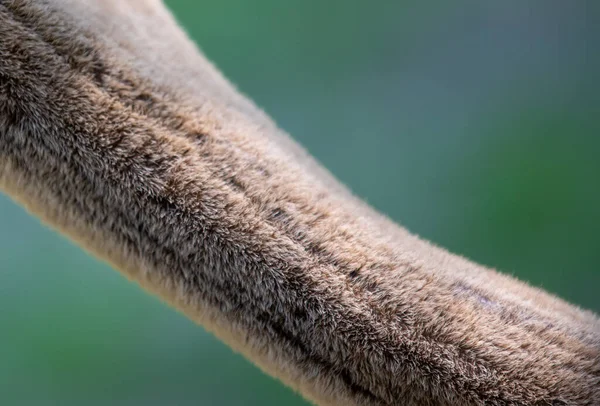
[{"left": 0, "top": 0, "right": 600, "bottom": 406}]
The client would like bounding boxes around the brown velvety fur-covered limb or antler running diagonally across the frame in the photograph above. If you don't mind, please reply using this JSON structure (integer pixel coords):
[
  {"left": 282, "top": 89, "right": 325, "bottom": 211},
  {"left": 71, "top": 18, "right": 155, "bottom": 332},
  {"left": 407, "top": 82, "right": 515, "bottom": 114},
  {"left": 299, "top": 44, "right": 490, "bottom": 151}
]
[{"left": 0, "top": 0, "right": 600, "bottom": 405}]
